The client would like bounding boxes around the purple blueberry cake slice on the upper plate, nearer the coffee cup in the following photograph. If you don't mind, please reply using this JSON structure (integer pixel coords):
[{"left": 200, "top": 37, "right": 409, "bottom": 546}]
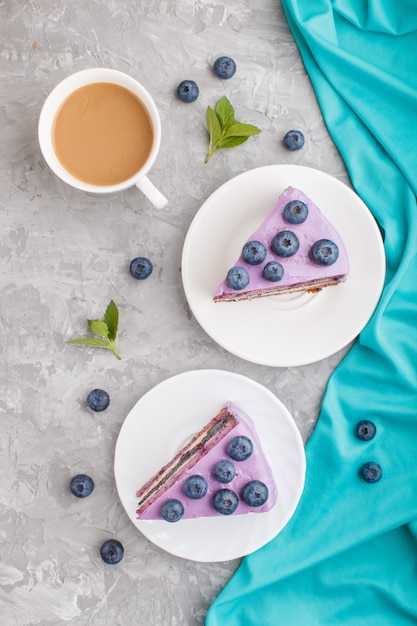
[{"left": 213, "top": 187, "right": 349, "bottom": 302}]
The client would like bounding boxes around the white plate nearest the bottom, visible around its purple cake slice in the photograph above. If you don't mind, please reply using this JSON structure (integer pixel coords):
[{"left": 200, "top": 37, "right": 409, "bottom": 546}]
[{"left": 114, "top": 370, "right": 305, "bottom": 562}]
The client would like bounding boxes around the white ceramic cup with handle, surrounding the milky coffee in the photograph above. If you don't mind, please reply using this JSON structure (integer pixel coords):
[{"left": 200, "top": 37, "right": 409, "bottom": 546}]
[{"left": 38, "top": 68, "right": 168, "bottom": 208}]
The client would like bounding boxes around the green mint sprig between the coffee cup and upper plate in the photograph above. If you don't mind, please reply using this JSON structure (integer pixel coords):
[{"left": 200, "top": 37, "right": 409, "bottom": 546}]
[{"left": 204, "top": 96, "right": 261, "bottom": 163}]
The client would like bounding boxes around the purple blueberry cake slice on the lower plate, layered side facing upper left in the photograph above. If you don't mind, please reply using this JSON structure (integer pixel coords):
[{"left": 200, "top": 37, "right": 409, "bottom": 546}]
[{"left": 136, "top": 402, "right": 277, "bottom": 522}]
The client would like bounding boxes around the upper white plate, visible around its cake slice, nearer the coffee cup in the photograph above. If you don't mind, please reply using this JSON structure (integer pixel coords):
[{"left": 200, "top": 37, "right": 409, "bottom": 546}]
[{"left": 182, "top": 165, "right": 385, "bottom": 367}]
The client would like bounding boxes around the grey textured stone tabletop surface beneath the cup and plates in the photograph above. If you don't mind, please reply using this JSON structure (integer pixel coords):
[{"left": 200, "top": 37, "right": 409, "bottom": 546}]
[{"left": 0, "top": 0, "right": 347, "bottom": 626}]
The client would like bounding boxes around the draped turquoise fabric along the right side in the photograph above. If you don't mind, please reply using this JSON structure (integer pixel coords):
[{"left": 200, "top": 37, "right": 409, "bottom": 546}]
[{"left": 206, "top": 0, "right": 417, "bottom": 626}]
